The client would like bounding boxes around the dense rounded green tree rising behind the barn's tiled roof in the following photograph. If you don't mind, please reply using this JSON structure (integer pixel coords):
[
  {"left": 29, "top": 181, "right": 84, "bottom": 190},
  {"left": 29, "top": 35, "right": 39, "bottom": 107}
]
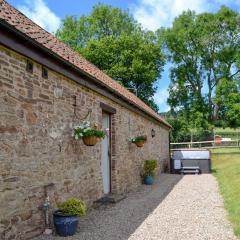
[{"left": 56, "top": 4, "right": 164, "bottom": 110}]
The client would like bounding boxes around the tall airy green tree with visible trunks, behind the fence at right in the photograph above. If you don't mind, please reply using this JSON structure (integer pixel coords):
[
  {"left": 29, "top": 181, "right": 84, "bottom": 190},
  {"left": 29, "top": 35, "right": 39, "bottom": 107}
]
[{"left": 164, "top": 6, "right": 240, "bottom": 125}]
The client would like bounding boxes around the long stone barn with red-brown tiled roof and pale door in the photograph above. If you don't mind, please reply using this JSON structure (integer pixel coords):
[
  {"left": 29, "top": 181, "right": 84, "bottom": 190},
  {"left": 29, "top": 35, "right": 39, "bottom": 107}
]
[{"left": 0, "top": 0, "right": 171, "bottom": 240}]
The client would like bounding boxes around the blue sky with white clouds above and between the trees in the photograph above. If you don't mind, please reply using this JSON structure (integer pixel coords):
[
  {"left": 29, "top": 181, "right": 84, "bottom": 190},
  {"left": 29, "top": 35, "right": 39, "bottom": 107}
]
[{"left": 7, "top": 0, "right": 240, "bottom": 112}]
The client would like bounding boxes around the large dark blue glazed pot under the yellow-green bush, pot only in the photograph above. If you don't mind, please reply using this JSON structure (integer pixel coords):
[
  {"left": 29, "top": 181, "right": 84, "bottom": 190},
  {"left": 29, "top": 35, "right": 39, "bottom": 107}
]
[{"left": 53, "top": 211, "right": 79, "bottom": 237}]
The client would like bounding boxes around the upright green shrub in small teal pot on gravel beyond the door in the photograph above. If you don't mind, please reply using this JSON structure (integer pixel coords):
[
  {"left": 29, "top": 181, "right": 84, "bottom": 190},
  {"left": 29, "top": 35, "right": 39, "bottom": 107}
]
[{"left": 143, "top": 160, "right": 157, "bottom": 185}]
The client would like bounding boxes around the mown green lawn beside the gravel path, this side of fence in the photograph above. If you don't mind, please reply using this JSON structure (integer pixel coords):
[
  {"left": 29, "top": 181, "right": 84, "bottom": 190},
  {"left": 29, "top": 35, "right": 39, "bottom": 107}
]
[{"left": 212, "top": 149, "right": 240, "bottom": 238}]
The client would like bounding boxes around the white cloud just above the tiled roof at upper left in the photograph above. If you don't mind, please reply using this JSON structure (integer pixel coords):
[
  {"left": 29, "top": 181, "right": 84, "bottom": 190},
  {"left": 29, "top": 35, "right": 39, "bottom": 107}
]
[{"left": 18, "top": 0, "right": 61, "bottom": 33}]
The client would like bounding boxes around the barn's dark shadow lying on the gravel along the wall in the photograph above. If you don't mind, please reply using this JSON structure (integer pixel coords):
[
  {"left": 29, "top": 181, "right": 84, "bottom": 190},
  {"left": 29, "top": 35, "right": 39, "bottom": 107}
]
[{"left": 36, "top": 174, "right": 182, "bottom": 240}]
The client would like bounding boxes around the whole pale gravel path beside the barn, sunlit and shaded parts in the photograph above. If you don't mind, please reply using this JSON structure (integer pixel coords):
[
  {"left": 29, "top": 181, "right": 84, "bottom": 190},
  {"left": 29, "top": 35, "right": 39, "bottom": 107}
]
[{"left": 36, "top": 174, "right": 236, "bottom": 240}]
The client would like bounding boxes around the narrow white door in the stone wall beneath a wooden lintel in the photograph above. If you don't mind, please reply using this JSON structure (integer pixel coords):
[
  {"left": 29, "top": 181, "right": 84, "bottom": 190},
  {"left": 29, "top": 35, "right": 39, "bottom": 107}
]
[{"left": 101, "top": 113, "right": 111, "bottom": 194}]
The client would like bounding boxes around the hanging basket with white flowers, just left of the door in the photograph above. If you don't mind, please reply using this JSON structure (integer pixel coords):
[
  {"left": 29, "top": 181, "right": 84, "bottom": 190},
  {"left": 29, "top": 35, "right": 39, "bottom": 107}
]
[{"left": 73, "top": 123, "right": 105, "bottom": 146}]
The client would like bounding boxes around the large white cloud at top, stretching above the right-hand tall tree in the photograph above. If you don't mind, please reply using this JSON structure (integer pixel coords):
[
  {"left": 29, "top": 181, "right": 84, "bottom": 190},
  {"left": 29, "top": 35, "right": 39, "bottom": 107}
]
[{"left": 130, "top": 0, "right": 240, "bottom": 30}]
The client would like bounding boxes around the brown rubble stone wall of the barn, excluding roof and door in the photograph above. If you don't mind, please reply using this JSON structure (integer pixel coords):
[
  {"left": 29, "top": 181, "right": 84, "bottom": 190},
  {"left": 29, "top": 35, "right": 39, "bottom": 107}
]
[{"left": 0, "top": 46, "right": 169, "bottom": 239}]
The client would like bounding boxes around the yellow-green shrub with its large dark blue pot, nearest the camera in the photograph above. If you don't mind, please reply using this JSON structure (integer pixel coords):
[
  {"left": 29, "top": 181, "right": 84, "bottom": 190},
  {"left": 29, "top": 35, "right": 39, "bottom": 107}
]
[{"left": 53, "top": 198, "right": 87, "bottom": 237}]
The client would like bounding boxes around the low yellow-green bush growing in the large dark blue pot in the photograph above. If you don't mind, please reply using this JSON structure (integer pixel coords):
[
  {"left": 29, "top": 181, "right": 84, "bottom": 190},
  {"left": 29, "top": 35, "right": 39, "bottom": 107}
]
[{"left": 57, "top": 198, "right": 87, "bottom": 216}]
